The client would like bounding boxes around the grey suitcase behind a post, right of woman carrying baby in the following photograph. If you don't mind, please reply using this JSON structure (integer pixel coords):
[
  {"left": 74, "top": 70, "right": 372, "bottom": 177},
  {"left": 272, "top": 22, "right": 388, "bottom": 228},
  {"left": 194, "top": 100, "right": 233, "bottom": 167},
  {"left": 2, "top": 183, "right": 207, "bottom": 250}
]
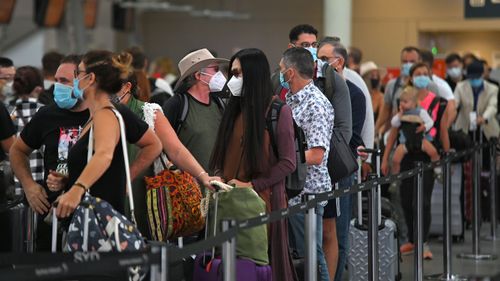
[{"left": 429, "top": 163, "right": 464, "bottom": 242}]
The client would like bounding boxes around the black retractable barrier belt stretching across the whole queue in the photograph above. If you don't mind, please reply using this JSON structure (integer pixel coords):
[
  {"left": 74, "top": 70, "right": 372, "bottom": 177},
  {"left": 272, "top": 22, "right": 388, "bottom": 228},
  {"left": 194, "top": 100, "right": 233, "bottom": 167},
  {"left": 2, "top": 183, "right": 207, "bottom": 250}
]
[{"left": 0, "top": 143, "right": 489, "bottom": 280}]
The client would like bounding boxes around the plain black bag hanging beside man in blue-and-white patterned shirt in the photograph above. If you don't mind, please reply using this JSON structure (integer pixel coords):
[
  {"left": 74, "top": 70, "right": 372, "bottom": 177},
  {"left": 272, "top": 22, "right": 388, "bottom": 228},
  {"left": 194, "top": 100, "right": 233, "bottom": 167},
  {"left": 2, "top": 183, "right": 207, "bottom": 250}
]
[{"left": 327, "top": 130, "right": 358, "bottom": 182}]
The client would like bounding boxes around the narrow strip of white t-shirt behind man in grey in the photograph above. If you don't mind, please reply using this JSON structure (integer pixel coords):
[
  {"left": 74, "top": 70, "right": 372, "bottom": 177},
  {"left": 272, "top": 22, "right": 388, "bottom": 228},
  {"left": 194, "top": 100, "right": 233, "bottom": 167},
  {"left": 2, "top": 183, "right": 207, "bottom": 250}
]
[{"left": 344, "top": 68, "right": 375, "bottom": 152}]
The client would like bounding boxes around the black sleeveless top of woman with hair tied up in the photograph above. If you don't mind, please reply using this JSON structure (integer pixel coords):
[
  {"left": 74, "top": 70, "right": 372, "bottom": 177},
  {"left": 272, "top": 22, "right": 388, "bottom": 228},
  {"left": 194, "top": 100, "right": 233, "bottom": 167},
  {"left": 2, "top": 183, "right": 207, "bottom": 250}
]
[{"left": 67, "top": 104, "right": 148, "bottom": 214}]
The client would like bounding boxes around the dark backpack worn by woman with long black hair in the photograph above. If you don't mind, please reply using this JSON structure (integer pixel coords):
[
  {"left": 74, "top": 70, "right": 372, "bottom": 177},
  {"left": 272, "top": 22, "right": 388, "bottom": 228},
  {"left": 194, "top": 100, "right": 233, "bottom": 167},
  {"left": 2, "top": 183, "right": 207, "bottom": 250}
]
[{"left": 266, "top": 99, "right": 307, "bottom": 199}]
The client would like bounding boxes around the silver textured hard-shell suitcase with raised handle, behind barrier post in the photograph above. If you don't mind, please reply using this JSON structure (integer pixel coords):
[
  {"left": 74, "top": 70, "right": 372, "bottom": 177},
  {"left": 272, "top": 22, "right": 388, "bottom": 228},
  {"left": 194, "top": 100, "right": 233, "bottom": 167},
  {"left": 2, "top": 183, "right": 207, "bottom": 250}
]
[{"left": 347, "top": 151, "right": 401, "bottom": 281}]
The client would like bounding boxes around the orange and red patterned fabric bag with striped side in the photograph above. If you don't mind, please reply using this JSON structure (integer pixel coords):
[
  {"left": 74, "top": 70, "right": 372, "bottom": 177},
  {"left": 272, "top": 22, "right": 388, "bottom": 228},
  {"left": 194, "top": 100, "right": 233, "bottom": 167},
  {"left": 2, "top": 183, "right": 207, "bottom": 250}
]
[{"left": 145, "top": 154, "right": 205, "bottom": 241}]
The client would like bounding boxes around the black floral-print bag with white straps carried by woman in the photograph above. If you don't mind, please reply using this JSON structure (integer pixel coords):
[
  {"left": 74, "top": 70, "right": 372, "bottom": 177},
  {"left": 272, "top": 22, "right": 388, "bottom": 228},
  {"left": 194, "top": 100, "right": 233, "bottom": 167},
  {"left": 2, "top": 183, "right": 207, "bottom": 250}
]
[{"left": 64, "top": 108, "right": 145, "bottom": 252}]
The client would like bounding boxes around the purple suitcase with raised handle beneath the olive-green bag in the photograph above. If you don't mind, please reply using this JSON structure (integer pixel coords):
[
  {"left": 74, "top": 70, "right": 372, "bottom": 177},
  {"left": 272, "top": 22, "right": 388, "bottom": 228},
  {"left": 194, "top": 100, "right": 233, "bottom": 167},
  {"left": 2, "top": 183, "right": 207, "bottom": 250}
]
[{"left": 193, "top": 183, "right": 273, "bottom": 281}]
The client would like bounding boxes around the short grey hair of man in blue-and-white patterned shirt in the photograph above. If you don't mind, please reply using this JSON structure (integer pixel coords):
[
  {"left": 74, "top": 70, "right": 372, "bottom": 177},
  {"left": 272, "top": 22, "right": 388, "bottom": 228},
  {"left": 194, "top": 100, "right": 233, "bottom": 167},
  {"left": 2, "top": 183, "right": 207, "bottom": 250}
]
[{"left": 283, "top": 48, "right": 314, "bottom": 79}]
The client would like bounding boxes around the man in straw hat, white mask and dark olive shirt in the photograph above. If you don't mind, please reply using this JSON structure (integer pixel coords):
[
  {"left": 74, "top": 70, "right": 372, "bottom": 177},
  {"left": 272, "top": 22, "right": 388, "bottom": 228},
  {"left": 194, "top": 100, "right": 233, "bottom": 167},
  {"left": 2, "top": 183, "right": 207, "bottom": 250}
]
[{"left": 163, "top": 49, "right": 228, "bottom": 171}]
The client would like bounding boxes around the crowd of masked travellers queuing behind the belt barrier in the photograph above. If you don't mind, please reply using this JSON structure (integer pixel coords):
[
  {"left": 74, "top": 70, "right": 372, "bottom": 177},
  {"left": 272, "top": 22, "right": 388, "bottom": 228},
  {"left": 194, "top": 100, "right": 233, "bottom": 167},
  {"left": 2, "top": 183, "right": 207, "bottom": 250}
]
[{"left": 0, "top": 24, "right": 500, "bottom": 281}]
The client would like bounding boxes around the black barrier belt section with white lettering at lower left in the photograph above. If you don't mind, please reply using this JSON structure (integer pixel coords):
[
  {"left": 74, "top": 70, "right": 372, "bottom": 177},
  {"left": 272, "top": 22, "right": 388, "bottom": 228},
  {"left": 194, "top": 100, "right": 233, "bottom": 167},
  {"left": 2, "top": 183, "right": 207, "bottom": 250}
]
[{"left": 0, "top": 249, "right": 160, "bottom": 281}]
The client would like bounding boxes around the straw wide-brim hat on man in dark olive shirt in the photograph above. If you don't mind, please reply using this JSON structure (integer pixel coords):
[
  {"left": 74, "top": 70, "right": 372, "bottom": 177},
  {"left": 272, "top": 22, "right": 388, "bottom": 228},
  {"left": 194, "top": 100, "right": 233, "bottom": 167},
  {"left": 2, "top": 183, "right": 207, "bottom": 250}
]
[{"left": 174, "top": 49, "right": 229, "bottom": 90}]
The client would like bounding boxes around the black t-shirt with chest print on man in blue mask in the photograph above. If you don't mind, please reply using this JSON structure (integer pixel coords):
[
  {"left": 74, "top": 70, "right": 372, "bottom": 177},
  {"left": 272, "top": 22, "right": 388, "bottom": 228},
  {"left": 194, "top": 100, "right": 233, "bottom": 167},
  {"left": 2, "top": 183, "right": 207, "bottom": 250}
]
[{"left": 21, "top": 105, "right": 89, "bottom": 201}]
